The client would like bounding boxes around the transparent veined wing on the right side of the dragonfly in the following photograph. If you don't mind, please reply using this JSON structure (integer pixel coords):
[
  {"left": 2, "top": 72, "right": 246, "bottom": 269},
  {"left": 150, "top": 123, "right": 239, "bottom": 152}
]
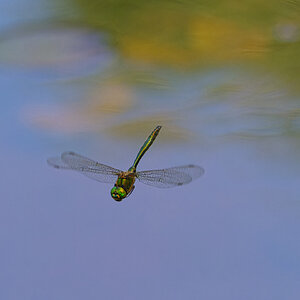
[{"left": 137, "top": 165, "right": 204, "bottom": 188}]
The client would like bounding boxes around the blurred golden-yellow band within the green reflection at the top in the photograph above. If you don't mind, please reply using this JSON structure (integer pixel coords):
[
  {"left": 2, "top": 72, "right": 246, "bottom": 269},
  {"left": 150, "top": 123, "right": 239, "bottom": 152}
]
[{"left": 119, "top": 11, "right": 272, "bottom": 67}]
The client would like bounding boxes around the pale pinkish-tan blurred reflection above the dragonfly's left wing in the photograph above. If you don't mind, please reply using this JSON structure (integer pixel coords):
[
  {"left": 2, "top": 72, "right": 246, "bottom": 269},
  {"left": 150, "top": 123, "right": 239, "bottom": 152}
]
[{"left": 25, "top": 83, "right": 135, "bottom": 133}]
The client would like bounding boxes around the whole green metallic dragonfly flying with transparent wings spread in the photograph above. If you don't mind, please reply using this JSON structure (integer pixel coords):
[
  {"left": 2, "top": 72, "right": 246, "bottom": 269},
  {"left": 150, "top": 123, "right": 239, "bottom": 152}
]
[{"left": 47, "top": 126, "right": 204, "bottom": 201}]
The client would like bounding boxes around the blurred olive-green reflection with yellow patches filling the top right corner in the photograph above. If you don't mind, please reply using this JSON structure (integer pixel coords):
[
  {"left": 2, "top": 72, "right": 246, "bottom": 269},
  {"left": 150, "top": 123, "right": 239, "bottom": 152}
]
[{"left": 68, "top": 0, "right": 300, "bottom": 90}]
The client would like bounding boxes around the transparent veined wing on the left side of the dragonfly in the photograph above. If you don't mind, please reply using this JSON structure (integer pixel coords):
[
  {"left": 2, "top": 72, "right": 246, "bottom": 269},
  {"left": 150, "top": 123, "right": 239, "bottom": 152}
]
[{"left": 47, "top": 152, "right": 121, "bottom": 183}]
